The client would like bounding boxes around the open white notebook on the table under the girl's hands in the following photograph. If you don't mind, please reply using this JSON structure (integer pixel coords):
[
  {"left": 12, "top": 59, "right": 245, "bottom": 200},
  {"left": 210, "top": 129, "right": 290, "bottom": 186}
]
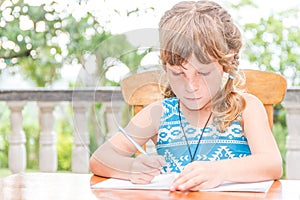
[{"left": 92, "top": 174, "right": 274, "bottom": 192}]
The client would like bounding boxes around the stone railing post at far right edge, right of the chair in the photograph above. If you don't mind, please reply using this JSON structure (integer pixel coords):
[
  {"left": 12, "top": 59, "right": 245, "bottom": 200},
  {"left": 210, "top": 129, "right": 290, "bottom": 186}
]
[{"left": 284, "top": 88, "right": 300, "bottom": 179}]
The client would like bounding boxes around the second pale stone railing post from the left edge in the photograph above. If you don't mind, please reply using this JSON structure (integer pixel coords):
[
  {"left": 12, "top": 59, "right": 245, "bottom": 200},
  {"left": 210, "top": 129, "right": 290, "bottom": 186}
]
[{"left": 38, "top": 102, "right": 57, "bottom": 172}]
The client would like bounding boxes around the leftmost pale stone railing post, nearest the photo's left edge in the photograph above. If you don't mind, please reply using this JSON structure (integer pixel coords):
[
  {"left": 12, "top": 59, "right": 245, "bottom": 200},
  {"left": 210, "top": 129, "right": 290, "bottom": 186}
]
[{"left": 7, "top": 101, "right": 26, "bottom": 173}]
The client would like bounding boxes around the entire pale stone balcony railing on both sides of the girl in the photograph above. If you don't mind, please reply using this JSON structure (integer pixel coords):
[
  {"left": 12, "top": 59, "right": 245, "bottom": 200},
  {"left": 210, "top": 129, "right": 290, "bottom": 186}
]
[{"left": 0, "top": 87, "right": 300, "bottom": 179}]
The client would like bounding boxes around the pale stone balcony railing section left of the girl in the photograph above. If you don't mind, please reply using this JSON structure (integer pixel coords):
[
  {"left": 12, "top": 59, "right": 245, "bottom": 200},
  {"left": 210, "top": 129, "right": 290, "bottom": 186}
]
[{"left": 0, "top": 87, "right": 123, "bottom": 173}]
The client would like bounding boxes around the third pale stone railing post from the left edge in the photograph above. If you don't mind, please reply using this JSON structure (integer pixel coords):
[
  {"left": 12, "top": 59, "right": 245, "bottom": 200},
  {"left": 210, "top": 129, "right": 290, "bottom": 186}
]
[{"left": 72, "top": 101, "right": 90, "bottom": 173}]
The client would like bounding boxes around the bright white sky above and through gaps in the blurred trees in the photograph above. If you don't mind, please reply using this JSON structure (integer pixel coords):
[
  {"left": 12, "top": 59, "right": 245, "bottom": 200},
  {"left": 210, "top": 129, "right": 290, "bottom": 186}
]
[{"left": 0, "top": 0, "right": 300, "bottom": 88}]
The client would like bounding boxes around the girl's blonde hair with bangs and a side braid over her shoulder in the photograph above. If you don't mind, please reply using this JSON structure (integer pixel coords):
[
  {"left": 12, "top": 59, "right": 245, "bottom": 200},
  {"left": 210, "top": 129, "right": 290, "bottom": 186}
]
[{"left": 159, "top": 0, "right": 246, "bottom": 131}]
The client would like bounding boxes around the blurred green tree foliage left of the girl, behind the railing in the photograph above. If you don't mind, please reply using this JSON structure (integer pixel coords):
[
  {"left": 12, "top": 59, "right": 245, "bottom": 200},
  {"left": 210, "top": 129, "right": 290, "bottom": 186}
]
[{"left": 0, "top": 0, "right": 147, "bottom": 170}]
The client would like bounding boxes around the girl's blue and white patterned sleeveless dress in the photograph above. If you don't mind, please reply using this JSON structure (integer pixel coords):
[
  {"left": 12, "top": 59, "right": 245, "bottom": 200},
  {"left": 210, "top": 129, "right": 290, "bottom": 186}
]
[{"left": 156, "top": 98, "right": 251, "bottom": 173}]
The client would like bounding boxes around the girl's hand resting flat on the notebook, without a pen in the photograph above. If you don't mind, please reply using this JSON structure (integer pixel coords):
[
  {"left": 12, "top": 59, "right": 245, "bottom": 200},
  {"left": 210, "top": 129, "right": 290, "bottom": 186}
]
[{"left": 170, "top": 161, "right": 224, "bottom": 191}]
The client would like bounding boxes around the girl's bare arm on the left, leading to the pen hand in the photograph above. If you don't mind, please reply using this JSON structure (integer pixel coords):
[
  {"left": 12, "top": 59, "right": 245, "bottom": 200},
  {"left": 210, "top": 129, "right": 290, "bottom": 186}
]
[{"left": 90, "top": 102, "right": 162, "bottom": 180}]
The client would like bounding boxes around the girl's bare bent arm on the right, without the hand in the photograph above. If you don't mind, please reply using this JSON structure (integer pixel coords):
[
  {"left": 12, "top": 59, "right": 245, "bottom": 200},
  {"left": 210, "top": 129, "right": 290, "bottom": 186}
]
[{"left": 220, "top": 95, "right": 282, "bottom": 182}]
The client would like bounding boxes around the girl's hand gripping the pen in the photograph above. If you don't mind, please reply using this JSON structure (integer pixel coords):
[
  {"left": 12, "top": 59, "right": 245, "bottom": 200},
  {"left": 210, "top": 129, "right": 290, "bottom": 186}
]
[{"left": 129, "top": 154, "right": 167, "bottom": 184}]
